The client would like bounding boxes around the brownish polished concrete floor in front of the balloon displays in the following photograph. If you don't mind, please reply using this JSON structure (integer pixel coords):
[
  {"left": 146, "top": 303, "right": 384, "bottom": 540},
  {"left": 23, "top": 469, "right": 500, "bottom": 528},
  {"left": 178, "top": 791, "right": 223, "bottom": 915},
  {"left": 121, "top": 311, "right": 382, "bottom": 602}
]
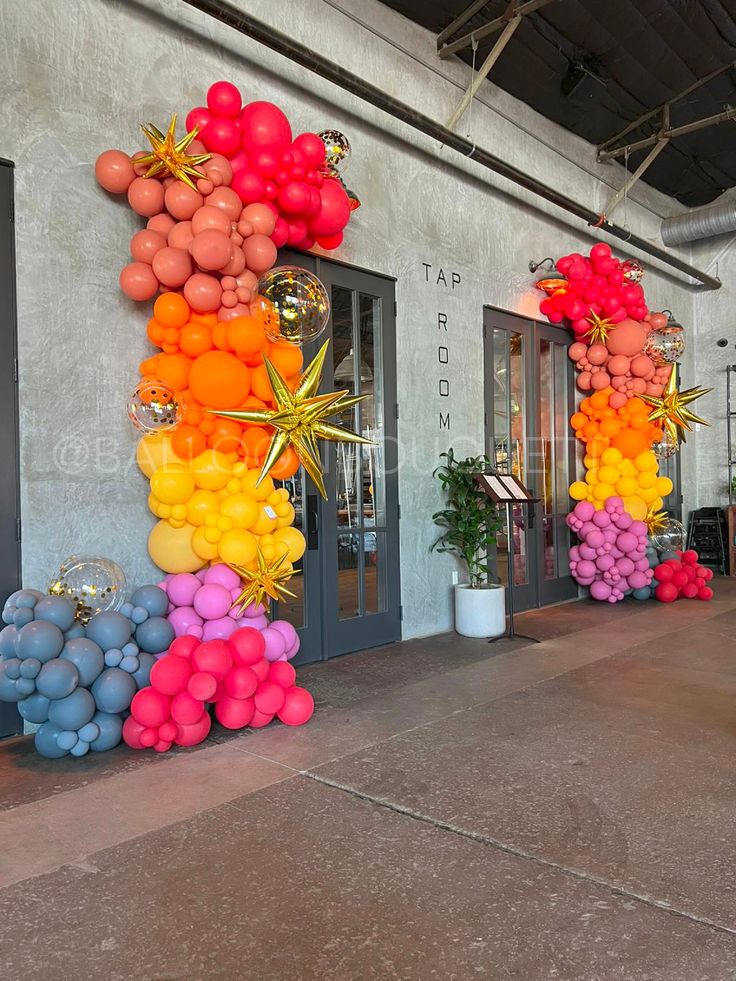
[{"left": 0, "top": 580, "right": 736, "bottom": 981}]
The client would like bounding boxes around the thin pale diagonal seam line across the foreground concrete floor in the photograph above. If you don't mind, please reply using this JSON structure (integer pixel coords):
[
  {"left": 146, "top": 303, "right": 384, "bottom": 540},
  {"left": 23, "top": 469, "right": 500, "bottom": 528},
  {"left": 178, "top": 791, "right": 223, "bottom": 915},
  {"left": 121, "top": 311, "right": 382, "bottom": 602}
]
[{"left": 300, "top": 770, "right": 736, "bottom": 937}]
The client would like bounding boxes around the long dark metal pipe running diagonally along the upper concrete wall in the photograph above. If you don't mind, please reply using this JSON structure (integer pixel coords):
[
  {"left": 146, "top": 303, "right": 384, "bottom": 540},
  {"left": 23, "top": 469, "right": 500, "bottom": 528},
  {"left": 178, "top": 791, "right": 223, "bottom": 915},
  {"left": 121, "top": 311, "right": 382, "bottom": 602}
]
[{"left": 177, "top": 0, "right": 721, "bottom": 290}]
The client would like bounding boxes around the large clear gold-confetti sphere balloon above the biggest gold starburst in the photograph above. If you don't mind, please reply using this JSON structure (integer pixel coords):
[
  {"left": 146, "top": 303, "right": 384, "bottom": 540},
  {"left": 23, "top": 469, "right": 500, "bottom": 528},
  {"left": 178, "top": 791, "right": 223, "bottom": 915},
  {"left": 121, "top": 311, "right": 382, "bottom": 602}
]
[{"left": 251, "top": 266, "right": 330, "bottom": 344}]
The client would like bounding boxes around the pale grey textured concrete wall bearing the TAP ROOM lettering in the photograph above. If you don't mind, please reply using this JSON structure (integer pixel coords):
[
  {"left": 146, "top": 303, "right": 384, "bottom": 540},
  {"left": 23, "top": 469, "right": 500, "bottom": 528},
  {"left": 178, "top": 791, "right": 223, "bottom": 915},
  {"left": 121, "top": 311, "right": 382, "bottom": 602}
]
[{"left": 0, "top": 0, "right": 710, "bottom": 636}]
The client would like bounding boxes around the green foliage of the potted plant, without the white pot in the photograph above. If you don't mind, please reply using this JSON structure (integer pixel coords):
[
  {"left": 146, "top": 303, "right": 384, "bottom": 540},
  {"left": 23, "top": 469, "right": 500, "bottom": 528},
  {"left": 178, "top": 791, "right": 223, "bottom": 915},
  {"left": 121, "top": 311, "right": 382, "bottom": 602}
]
[{"left": 431, "top": 447, "right": 503, "bottom": 589}]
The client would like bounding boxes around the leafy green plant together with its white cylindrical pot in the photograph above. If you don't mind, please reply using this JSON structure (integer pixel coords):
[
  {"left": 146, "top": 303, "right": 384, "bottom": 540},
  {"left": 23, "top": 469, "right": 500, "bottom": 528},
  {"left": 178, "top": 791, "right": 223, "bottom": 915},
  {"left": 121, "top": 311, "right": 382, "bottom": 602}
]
[{"left": 432, "top": 448, "right": 506, "bottom": 637}]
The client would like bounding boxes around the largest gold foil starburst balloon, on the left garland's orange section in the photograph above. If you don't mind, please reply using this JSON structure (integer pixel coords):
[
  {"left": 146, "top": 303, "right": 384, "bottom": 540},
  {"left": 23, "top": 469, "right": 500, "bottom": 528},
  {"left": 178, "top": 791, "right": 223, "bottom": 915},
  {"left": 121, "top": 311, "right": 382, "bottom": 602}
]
[{"left": 213, "top": 341, "right": 372, "bottom": 500}]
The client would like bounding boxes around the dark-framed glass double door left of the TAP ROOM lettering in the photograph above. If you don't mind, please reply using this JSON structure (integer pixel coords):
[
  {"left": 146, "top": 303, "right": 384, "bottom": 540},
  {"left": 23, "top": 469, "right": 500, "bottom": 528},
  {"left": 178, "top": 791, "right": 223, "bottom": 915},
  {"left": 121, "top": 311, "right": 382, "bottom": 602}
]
[{"left": 274, "top": 253, "right": 401, "bottom": 664}]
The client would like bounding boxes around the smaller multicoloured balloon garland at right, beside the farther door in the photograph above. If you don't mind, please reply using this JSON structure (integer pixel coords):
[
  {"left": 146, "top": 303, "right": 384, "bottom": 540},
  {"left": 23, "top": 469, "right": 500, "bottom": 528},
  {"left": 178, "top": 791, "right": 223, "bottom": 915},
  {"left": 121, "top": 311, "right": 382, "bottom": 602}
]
[{"left": 537, "top": 242, "right": 713, "bottom": 603}]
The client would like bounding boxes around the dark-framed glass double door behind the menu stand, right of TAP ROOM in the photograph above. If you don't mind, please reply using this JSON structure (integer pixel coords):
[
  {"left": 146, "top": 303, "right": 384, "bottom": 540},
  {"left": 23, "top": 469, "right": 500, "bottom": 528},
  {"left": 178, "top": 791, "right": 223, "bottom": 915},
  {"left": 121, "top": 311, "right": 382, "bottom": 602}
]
[{"left": 483, "top": 308, "right": 577, "bottom": 610}]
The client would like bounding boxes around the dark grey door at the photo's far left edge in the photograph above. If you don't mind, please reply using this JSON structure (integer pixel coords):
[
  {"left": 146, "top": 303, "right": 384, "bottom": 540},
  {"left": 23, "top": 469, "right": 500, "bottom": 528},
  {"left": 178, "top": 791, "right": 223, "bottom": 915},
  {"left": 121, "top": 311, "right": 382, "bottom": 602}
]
[{"left": 0, "top": 158, "right": 21, "bottom": 736}]
